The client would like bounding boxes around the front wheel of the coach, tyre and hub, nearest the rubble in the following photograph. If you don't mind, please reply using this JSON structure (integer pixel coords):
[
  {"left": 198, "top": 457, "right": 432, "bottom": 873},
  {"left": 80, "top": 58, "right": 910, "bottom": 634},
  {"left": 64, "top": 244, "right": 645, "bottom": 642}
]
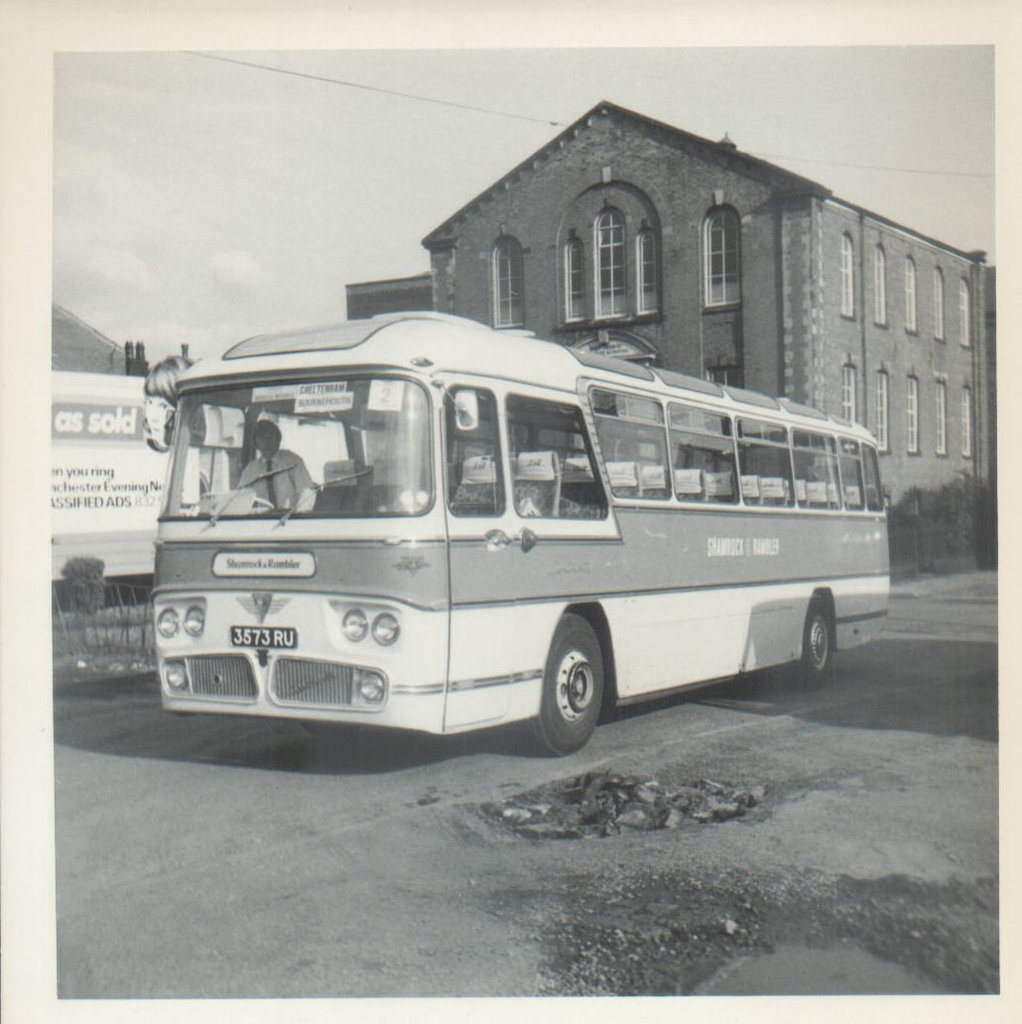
[{"left": 531, "top": 614, "right": 603, "bottom": 757}]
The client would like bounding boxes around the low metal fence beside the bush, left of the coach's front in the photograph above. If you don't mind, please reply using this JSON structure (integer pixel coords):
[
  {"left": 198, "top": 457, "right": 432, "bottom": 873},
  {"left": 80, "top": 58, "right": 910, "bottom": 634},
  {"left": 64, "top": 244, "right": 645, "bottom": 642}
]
[{"left": 52, "top": 583, "right": 156, "bottom": 660}]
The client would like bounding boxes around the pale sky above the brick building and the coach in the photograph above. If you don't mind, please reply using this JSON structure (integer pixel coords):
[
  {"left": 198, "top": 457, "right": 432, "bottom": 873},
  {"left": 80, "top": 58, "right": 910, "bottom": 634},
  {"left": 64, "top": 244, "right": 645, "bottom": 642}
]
[{"left": 53, "top": 46, "right": 995, "bottom": 361}]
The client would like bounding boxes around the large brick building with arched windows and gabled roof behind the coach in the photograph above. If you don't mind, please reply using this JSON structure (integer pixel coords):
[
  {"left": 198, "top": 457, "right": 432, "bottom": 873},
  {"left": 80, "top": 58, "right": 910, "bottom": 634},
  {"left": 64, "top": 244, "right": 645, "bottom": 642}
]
[{"left": 348, "top": 102, "right": 993, "bottom": 500}]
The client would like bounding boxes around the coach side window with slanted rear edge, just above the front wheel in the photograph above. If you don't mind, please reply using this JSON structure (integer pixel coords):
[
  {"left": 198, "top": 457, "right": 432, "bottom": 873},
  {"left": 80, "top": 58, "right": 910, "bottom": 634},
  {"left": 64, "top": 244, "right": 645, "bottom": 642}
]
[{"left": 507, "top": 395, "right": 607, "bottom": 519}]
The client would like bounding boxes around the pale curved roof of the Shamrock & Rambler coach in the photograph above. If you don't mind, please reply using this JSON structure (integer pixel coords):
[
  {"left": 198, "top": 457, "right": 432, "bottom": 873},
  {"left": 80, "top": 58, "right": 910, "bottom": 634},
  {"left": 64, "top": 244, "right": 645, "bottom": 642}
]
[{"left": 179, "top": 312, "right": 871, "bottom": 440}]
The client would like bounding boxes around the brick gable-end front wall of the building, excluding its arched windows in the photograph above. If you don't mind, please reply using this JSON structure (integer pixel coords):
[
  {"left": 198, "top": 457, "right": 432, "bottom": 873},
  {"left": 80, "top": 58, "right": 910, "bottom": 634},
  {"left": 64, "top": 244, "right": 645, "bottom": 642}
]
[{"left": 432, "top": 109, "right": 780, "bottom": 392}]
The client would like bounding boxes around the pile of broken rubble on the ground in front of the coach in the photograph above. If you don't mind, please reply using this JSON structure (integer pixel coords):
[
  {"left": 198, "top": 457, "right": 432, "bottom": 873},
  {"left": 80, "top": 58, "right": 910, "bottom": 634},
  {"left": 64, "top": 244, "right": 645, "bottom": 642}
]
[{"left": 486, "top": 771, "right": 764, "bottom": 839}]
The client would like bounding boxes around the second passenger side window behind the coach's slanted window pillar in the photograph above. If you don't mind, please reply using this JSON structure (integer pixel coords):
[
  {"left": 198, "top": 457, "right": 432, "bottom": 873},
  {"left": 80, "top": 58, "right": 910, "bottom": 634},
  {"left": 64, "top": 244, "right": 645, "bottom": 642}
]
[{"left": 669, "top": 402, "right": 738, "bottom": 505}]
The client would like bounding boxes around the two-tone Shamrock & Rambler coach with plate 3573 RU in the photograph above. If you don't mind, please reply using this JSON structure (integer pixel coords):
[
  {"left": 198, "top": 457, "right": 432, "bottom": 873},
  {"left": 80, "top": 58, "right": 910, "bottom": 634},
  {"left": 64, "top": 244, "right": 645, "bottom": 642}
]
[{"left": 154, "top": 312, "right": 889, "bottom": 756}]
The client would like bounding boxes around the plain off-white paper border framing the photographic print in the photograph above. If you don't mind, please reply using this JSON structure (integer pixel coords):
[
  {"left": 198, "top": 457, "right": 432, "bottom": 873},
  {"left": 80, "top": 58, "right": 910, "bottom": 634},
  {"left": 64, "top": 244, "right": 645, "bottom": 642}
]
[{"left": 0, "top": 0, "right": 1022, "bottom": 1024}]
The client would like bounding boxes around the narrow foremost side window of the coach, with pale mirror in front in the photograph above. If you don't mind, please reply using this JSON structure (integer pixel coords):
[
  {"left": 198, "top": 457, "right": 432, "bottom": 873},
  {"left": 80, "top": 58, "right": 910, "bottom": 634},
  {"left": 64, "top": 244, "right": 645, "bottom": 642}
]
[{"left": 443, "top": 388, "right": 504, "bottom": 516}]
